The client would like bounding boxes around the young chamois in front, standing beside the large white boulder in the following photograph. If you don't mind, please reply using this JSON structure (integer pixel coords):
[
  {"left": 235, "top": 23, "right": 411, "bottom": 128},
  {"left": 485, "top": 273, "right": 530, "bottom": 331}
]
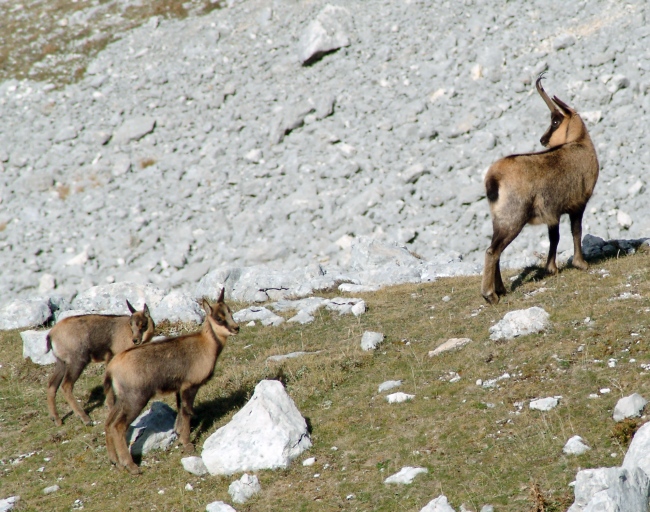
[{"left": 104, "top": 290, "right": 239, "bottom": 474}]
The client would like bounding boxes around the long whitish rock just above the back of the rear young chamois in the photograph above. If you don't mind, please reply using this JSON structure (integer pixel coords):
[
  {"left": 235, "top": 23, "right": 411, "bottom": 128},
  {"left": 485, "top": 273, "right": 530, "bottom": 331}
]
[{"left": 72, "top": 282, "right": 166, "bottom": 315}]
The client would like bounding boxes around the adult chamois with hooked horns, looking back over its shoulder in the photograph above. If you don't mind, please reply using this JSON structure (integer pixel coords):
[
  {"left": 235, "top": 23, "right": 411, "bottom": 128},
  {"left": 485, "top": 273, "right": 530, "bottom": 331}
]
[{"left": 481, "top": 73, "right": 598, "bottom": 304}]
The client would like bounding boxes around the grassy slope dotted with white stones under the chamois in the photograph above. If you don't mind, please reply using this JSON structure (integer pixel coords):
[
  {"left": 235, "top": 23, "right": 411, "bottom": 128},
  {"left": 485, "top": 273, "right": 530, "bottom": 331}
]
[{"left": 0, "top": 248, "right": 650, "bottom": 511}]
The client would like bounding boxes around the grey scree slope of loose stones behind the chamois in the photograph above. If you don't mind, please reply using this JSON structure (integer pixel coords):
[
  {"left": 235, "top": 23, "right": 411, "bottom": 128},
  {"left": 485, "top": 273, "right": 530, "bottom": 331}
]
[{"left": 0, "top": 0, "right": 650, "bottom": 300}]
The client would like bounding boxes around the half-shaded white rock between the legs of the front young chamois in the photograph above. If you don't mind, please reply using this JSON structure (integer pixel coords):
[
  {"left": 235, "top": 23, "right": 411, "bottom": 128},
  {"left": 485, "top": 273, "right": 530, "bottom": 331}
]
[{"left": 126, "top": 402, "right": 178, "bottom": 455}]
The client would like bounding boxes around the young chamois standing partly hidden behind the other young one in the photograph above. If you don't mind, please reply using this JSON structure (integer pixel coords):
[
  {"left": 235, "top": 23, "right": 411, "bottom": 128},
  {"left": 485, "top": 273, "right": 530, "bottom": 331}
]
[{"left": 47, "top": 300, "right": 155, "bottom": 426}]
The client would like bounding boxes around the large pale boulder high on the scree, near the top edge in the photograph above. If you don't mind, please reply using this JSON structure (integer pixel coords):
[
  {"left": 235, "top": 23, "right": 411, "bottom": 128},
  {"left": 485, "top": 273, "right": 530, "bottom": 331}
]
[{"left": 298, "top": 5, "right": 352, "bottom": 64}]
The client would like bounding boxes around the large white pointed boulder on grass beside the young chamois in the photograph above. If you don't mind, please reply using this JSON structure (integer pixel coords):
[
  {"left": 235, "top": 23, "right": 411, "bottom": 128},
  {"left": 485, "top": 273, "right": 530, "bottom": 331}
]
[{"left": 201, "top": 380, "right": 311, "bottom": 475}]
